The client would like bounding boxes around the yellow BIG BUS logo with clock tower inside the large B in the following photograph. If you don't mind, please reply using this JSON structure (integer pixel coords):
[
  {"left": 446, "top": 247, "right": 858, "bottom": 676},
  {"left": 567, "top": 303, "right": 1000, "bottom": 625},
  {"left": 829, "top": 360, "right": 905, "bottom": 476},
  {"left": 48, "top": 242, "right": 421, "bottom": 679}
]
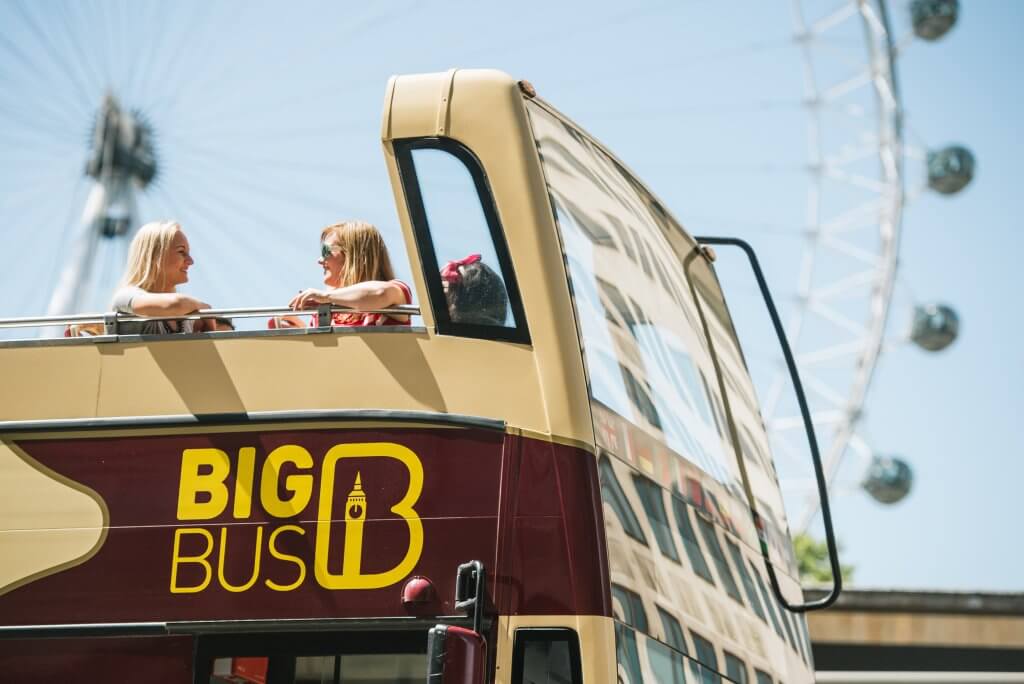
[{"left": 170, "top": 442, "right": 423, "bottom": 594}]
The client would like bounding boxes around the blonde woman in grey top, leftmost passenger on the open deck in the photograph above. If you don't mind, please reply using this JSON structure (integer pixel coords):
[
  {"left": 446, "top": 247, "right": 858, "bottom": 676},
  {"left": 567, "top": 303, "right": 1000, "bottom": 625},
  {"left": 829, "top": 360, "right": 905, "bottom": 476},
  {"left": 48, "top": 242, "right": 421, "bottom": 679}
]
[{"left": 112, "top": 221, "right": 216, "bottom": 335}]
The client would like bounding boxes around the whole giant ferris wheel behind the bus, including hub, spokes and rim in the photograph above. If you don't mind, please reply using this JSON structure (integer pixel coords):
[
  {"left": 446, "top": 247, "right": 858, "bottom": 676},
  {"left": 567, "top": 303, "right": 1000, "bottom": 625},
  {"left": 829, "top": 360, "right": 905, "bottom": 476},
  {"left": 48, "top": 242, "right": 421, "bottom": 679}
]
[{"left": 0, "top": 0, "right": 975, "bottom": 544}]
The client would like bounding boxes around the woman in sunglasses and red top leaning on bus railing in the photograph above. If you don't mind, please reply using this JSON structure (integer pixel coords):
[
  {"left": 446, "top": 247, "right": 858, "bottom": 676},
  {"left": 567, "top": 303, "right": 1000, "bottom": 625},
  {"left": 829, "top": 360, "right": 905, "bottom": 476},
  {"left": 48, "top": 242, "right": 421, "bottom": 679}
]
[{"left": 281, "top": 221, "right": 413, "bottom": 327}]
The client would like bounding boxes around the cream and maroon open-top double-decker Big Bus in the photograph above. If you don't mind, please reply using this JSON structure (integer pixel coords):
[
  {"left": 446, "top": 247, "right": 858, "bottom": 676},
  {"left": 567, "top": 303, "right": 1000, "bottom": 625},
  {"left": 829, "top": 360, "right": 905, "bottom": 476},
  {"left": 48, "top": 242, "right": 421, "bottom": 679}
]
[{"left": 0, "top": 70, "right": 831, "bottom": 684}]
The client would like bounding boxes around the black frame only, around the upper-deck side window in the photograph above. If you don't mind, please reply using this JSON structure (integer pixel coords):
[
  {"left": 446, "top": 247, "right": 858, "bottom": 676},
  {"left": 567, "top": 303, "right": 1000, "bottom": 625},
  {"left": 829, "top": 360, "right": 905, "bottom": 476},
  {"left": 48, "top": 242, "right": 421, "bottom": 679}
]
[{"left": 393, "top": 137, "right": 531, "bottom": 345}]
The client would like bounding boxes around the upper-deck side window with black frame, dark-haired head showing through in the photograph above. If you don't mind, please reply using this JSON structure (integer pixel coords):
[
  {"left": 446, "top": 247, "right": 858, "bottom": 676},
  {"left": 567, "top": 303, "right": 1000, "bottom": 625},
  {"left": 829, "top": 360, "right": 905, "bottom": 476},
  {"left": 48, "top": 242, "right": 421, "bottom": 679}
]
[{"left": 395, "top": 138, "right": 529, "bottom": 344}]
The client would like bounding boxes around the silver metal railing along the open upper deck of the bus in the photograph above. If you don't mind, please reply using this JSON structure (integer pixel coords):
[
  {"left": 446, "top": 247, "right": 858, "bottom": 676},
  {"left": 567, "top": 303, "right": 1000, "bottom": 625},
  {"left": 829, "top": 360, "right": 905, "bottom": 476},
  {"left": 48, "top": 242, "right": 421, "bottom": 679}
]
[{"left": 0, "top": 304, "right": 420, "bottom": 336}]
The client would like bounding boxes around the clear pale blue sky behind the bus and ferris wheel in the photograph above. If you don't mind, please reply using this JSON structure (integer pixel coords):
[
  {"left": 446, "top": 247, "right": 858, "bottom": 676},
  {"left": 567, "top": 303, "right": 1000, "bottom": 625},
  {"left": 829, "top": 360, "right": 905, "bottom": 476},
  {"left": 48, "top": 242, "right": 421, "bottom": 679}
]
[{"left": 0, "top": 0, "right": 1024, "bottom": 591}]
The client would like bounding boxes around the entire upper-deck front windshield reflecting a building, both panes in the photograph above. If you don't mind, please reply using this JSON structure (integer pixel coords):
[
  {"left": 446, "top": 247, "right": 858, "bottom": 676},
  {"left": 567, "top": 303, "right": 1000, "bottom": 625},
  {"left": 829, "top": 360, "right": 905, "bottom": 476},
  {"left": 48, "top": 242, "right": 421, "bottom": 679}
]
[{"left": 527, "top": 100, "right": 792, "bottom": 566}]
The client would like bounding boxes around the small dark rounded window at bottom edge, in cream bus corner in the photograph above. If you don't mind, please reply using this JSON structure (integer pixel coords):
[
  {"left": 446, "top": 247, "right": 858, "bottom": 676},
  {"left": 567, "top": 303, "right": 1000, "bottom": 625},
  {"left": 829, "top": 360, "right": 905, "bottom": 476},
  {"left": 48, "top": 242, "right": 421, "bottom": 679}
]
[{"left": 512, "top": 629, "right": 583, "bottom": 684}]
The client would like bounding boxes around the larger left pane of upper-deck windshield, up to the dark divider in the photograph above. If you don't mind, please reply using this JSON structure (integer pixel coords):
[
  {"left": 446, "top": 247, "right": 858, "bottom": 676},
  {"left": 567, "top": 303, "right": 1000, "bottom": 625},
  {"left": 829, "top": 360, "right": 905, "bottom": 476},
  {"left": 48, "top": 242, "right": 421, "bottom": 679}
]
[{"left": 526, "top": 100, "right": 754, "bottom": 497}]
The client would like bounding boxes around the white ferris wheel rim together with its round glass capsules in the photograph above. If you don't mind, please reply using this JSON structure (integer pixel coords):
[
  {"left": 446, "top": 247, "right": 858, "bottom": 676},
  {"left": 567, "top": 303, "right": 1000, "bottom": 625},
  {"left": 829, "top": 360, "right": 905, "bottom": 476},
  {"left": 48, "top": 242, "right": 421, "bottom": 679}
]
[{"left": 729, "top": 0, "right": 975, "bottom": 531}]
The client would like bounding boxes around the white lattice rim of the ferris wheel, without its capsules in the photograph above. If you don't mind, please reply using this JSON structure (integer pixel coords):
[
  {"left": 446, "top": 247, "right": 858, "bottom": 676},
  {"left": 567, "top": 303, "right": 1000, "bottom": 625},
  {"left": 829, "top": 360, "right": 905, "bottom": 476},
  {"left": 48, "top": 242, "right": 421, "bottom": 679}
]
[{"left": 765, "top": 0, "right": 904, "bottom": 531}]
